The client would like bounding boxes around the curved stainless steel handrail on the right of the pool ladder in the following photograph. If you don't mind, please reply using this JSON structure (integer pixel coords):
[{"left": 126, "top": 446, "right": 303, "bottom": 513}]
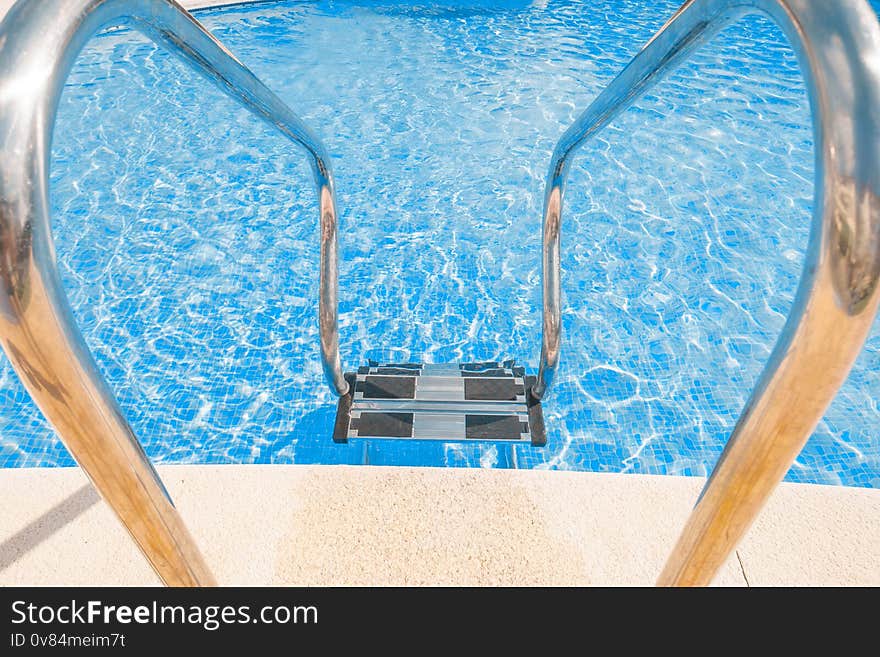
[{"left": 536, "top": 0, "right": 880, "bottom": 585}]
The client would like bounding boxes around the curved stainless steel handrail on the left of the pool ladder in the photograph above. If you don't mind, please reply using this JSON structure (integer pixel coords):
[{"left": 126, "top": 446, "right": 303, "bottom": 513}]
[{"left": 0, "top": 0, "right": 348, "bottom": 585}]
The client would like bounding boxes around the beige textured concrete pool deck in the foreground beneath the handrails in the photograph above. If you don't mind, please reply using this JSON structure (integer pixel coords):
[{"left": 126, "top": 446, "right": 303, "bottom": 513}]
[{"left": 0, "top": 465, "right": 880, "bottom": 586}]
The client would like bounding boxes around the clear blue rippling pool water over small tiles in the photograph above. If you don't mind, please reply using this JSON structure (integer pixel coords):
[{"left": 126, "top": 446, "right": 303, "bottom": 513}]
[{"left": 0, "top": 0, "right": 880, "bottom": 487}]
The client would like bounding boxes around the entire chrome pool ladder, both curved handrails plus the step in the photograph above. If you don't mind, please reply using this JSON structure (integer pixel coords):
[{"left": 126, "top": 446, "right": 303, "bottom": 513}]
[{"left": 0, "top": 0, "right": 880, "bottom": 585}]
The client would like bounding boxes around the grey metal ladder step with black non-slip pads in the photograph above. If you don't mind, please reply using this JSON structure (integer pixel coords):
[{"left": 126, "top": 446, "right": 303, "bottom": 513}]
[{"left": 333, "top": 361, "right": 547, "bottom": 446}]
